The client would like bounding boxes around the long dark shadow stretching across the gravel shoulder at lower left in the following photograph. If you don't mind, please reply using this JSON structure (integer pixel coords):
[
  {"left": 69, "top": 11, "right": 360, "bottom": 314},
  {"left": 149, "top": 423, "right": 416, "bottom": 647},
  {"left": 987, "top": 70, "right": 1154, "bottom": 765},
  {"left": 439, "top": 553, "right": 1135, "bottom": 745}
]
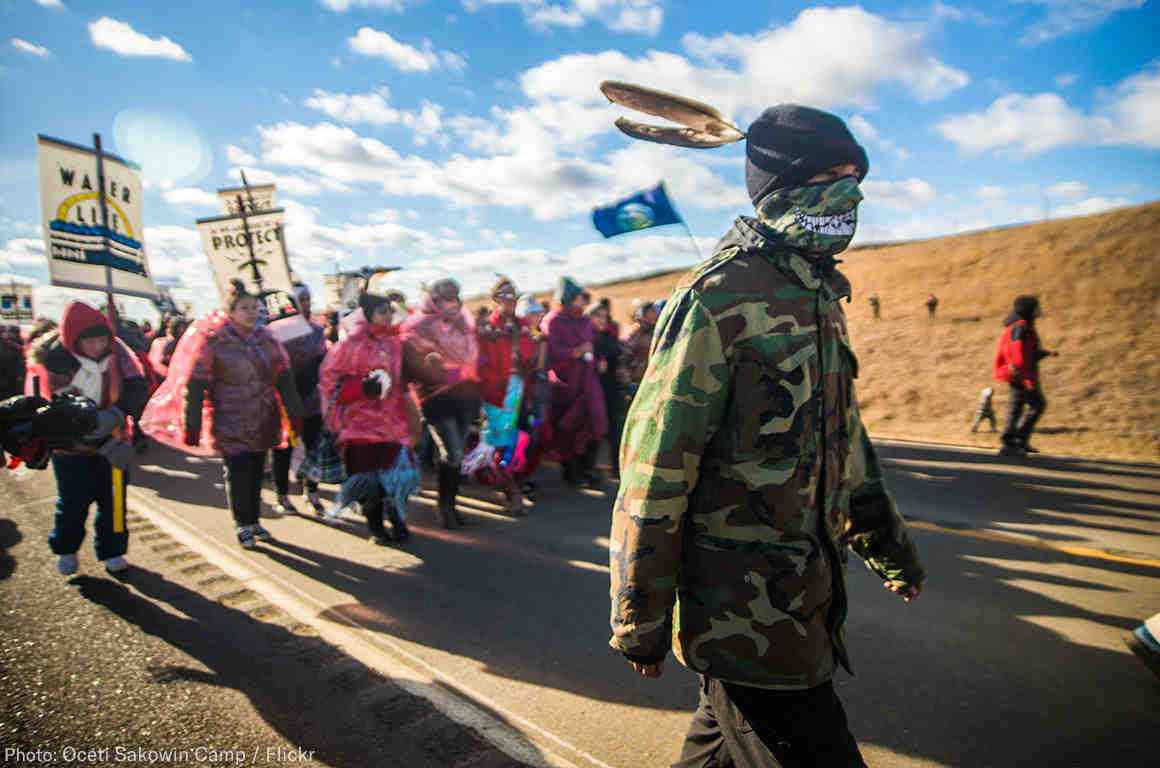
[{"left": 72, "top": 567, "right": 542, "bottom": 768}]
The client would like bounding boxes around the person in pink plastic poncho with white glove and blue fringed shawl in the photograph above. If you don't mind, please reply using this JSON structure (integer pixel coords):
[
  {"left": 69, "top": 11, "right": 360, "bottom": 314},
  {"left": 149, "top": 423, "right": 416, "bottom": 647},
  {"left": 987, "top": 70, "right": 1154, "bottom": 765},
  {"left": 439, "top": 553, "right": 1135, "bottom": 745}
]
[{"left": 319, "top": 285, "right": 444, "bottom": 545}]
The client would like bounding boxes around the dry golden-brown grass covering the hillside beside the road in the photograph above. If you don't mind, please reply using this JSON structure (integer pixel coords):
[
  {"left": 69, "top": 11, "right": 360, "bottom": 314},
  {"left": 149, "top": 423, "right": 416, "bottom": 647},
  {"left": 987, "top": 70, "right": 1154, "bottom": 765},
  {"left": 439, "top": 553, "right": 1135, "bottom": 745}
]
[{"left": 468, "top": 202, "right": 1160, "bottom": 462}]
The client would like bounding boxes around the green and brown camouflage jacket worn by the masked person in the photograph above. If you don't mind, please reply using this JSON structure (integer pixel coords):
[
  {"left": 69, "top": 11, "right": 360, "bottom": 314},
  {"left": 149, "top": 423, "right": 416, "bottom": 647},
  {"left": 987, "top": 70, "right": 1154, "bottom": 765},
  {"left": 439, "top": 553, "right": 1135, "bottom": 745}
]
[{"left": 609, "top": 218, "right": 925, "bottom": 689}]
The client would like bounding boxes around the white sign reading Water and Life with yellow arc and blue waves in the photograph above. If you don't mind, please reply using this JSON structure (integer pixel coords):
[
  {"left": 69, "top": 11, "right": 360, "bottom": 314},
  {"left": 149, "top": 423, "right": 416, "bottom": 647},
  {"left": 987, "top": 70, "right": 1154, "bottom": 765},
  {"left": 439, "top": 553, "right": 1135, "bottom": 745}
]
[{"left": 36, "top": 136, "right": 157, "bottom": 298}]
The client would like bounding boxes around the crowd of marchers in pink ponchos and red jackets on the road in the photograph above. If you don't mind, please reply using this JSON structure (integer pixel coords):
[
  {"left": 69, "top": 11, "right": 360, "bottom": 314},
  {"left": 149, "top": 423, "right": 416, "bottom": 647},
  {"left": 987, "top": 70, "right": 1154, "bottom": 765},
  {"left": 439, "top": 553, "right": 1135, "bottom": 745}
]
[{"left": 0, "top": 276, "right": 664, "bottom": 575}]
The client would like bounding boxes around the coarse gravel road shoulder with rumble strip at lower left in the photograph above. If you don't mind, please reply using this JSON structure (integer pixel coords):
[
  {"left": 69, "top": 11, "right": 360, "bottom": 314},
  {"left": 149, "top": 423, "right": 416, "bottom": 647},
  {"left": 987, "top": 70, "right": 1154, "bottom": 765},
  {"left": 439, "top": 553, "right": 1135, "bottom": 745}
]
[{"left": 0, "top": 472, "right": 521, "bottom": 768}]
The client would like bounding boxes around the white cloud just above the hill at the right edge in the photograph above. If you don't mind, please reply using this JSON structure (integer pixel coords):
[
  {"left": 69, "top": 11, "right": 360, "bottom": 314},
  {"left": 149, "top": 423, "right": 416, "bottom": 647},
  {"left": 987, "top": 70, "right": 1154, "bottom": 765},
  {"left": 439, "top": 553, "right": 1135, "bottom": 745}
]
[{"left": 936, "top": 61, "right": 1160, "bottom": 154}]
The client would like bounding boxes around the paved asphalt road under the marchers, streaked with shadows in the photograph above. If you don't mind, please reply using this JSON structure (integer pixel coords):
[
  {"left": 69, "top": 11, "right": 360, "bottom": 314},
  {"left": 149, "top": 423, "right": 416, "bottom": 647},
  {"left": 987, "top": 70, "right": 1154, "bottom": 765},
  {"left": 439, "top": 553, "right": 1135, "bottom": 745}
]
[{"left": 18, "top": 444, "right": 1160, "bottom": 767}]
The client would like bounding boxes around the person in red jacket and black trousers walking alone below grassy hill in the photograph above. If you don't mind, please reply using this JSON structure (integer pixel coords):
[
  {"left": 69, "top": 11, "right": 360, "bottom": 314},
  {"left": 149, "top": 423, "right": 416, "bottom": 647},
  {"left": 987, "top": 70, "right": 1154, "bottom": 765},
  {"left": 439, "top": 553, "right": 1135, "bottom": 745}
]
[{"left": 993, "top": 296, "right": 1059, "bottom": 456}]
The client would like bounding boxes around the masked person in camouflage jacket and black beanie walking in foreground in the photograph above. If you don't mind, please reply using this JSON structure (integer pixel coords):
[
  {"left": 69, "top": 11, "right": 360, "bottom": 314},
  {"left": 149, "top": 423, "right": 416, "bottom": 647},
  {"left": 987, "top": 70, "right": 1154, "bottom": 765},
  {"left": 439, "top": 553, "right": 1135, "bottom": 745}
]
[{"left": 610, "top": 104, "right": 925, "bottom": 767}]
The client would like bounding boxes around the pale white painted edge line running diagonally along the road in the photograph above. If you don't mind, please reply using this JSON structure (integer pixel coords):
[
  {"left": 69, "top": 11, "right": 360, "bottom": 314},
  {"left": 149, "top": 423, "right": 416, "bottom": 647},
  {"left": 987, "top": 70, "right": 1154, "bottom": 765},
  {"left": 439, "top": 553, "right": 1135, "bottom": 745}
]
[{"left": 129, "top": 486, "right": 612, "bottom": 768}]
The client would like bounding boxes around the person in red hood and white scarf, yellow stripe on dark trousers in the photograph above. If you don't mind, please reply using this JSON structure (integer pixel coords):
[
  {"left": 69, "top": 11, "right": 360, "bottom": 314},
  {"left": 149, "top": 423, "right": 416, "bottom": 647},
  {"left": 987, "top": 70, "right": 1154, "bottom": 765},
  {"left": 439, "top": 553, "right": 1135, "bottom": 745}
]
[{"left": 26, "top": 302, "right": 148, "bottom": 575}]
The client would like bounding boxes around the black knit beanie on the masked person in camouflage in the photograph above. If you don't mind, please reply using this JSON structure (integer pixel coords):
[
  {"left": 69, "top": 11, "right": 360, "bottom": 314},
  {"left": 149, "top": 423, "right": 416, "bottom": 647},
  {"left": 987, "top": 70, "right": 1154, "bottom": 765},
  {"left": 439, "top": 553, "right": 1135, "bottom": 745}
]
[{"left": 745, "top": 104, "right": 870, "bottom": 205}]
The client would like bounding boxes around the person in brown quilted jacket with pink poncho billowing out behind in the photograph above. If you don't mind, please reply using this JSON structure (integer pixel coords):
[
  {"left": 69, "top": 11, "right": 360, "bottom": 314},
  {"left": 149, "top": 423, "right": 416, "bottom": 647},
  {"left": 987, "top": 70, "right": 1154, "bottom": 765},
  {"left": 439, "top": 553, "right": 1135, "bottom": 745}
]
[{"left": 142, "top": 280, "right": 303, "bottom": 549}]
